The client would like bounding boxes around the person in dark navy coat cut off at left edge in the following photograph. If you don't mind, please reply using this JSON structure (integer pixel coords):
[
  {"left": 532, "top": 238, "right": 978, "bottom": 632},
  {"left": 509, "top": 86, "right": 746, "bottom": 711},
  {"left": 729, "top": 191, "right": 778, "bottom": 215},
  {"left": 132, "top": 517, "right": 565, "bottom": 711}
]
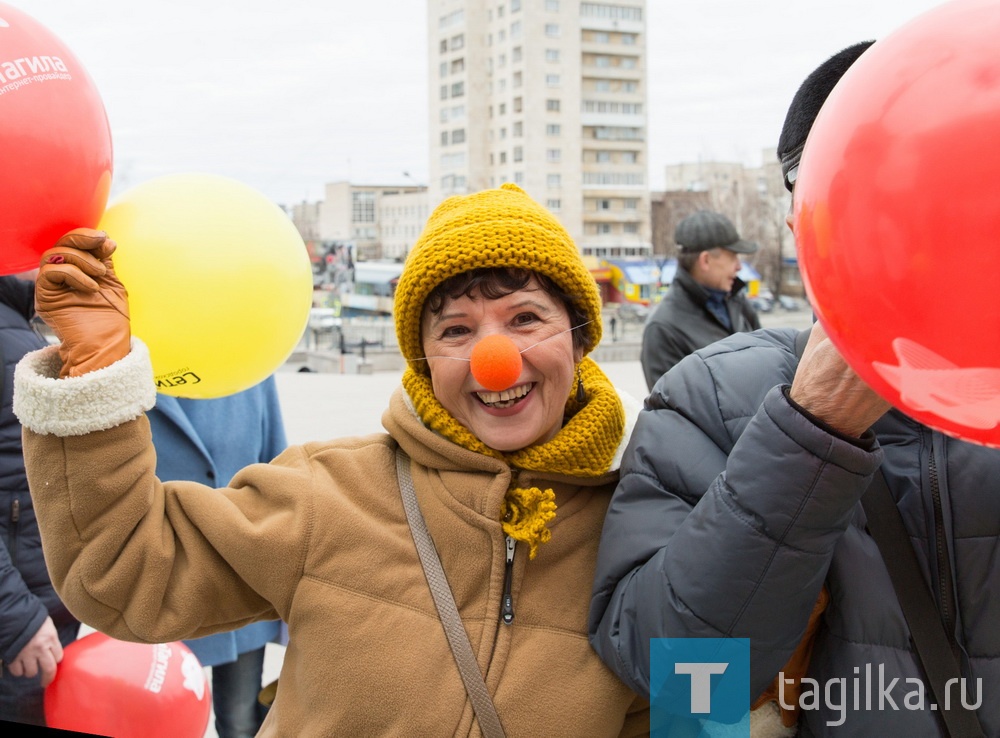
[{"left": 0, "top": 275, "right": 80, "bottom": 725}]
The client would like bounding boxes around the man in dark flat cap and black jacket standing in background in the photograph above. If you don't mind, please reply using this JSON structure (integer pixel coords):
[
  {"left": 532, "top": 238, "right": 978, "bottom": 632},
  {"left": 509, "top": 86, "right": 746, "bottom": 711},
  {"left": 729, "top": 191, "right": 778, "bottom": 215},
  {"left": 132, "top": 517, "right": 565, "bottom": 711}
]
[{"left": 640, "top": 210, "right": 760, "bottom": 390}]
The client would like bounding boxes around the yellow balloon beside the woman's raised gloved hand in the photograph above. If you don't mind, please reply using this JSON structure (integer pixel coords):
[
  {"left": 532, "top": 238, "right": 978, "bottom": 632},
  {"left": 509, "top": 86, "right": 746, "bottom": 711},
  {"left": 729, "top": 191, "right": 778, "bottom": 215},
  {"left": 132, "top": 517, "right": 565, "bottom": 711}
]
[{"left": 98, "top": 174, "right": 313, "bottom": 398}]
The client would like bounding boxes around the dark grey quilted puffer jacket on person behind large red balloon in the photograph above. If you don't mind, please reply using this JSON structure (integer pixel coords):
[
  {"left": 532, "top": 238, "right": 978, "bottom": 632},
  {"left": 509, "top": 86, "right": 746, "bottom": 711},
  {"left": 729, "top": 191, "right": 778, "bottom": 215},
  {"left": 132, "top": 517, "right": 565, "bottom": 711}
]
[{"left": 590, "top": 329, "right": 1000, "bottom": 737}]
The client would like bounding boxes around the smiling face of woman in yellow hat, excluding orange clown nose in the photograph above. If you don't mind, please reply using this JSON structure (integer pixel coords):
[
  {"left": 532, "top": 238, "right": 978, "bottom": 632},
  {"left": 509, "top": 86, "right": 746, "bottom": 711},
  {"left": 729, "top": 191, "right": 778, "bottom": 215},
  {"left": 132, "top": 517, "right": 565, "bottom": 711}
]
[{"left": 421, "top": 277, "right": 583, "bottom": 451}]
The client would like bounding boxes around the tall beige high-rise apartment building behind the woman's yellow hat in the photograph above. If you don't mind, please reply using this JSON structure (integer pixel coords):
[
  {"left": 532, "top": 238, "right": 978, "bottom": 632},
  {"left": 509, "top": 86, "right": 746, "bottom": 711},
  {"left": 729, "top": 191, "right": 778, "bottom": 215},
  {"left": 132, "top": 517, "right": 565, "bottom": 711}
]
[{"left": 428, "top": 0, "right": 651, "bottom": 257}]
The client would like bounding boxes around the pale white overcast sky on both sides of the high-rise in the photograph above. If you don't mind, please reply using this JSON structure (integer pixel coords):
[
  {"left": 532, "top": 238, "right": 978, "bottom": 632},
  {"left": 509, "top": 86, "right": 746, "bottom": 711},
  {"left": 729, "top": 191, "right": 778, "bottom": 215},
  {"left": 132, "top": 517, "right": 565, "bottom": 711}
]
[{"left": 0, "top": 0, "right": 941, "bottom": 205}]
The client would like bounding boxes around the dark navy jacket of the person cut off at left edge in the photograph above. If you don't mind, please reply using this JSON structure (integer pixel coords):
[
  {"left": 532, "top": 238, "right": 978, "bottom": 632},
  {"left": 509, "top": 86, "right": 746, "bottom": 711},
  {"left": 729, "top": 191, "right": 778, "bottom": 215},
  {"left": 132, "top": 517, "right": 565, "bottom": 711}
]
[{"left": 0, "top": 276, "right": 79, "bottom": 664}]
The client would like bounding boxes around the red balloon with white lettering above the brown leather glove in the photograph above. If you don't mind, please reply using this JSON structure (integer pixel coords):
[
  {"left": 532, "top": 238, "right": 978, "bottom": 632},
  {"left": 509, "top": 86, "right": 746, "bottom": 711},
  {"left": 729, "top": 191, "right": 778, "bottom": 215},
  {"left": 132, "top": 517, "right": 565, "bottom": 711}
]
[{"left": 0, "top": 3, "right": 111, "bottom": 274}]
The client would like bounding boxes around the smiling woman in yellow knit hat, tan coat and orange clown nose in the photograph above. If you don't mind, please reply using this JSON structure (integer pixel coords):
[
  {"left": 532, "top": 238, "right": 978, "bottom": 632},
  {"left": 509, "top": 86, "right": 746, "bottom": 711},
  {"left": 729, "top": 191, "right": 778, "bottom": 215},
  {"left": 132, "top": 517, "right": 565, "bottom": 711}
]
[{"left": 15, "top": 185, "right": 649, "bottom": 738}]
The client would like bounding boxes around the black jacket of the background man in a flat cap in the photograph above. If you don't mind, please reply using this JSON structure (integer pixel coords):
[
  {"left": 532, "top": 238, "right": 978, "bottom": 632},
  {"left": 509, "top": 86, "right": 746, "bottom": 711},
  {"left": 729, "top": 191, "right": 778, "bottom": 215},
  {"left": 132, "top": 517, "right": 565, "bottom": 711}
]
[{"left": 640, "top": 268, "right": 760, "bottom": 389}]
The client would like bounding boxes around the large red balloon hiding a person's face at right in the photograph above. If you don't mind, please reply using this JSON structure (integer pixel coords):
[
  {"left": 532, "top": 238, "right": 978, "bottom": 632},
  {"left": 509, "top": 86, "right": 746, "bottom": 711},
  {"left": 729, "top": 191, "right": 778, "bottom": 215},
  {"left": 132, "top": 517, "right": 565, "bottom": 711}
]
[{"left": 795, "top": 0, "right": 1000, "bottom": 447}]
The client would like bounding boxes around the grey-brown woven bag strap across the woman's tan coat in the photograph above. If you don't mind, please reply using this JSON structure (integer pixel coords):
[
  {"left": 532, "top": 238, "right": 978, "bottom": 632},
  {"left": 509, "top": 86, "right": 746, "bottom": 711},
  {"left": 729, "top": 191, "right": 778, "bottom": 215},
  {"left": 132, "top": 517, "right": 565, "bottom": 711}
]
[{"left": 396, "top": 447, "right": 505, "bottom": 738}]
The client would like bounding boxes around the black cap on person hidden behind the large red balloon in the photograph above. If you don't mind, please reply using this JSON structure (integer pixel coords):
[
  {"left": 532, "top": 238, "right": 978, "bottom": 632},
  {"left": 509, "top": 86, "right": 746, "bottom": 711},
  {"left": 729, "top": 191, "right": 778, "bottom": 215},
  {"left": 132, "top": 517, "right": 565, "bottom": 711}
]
[{"left": 778, "top": 41, "right": 875, "bottom": 192}]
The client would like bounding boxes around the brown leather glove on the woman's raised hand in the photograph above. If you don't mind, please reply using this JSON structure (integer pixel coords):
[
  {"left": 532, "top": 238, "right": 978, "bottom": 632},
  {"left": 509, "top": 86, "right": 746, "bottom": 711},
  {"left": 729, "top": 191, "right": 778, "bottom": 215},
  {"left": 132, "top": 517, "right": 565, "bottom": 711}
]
[{"left": 35, "top": 228, "right": 131, "bottom": 378}]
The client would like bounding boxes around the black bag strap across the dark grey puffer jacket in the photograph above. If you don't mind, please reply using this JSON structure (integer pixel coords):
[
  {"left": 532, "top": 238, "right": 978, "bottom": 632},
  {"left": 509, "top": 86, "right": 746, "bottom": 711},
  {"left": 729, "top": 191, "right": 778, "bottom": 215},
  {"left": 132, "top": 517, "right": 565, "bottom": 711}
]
[{"left": 861, "top": 470, "right": 985, "bottom": 738}]
